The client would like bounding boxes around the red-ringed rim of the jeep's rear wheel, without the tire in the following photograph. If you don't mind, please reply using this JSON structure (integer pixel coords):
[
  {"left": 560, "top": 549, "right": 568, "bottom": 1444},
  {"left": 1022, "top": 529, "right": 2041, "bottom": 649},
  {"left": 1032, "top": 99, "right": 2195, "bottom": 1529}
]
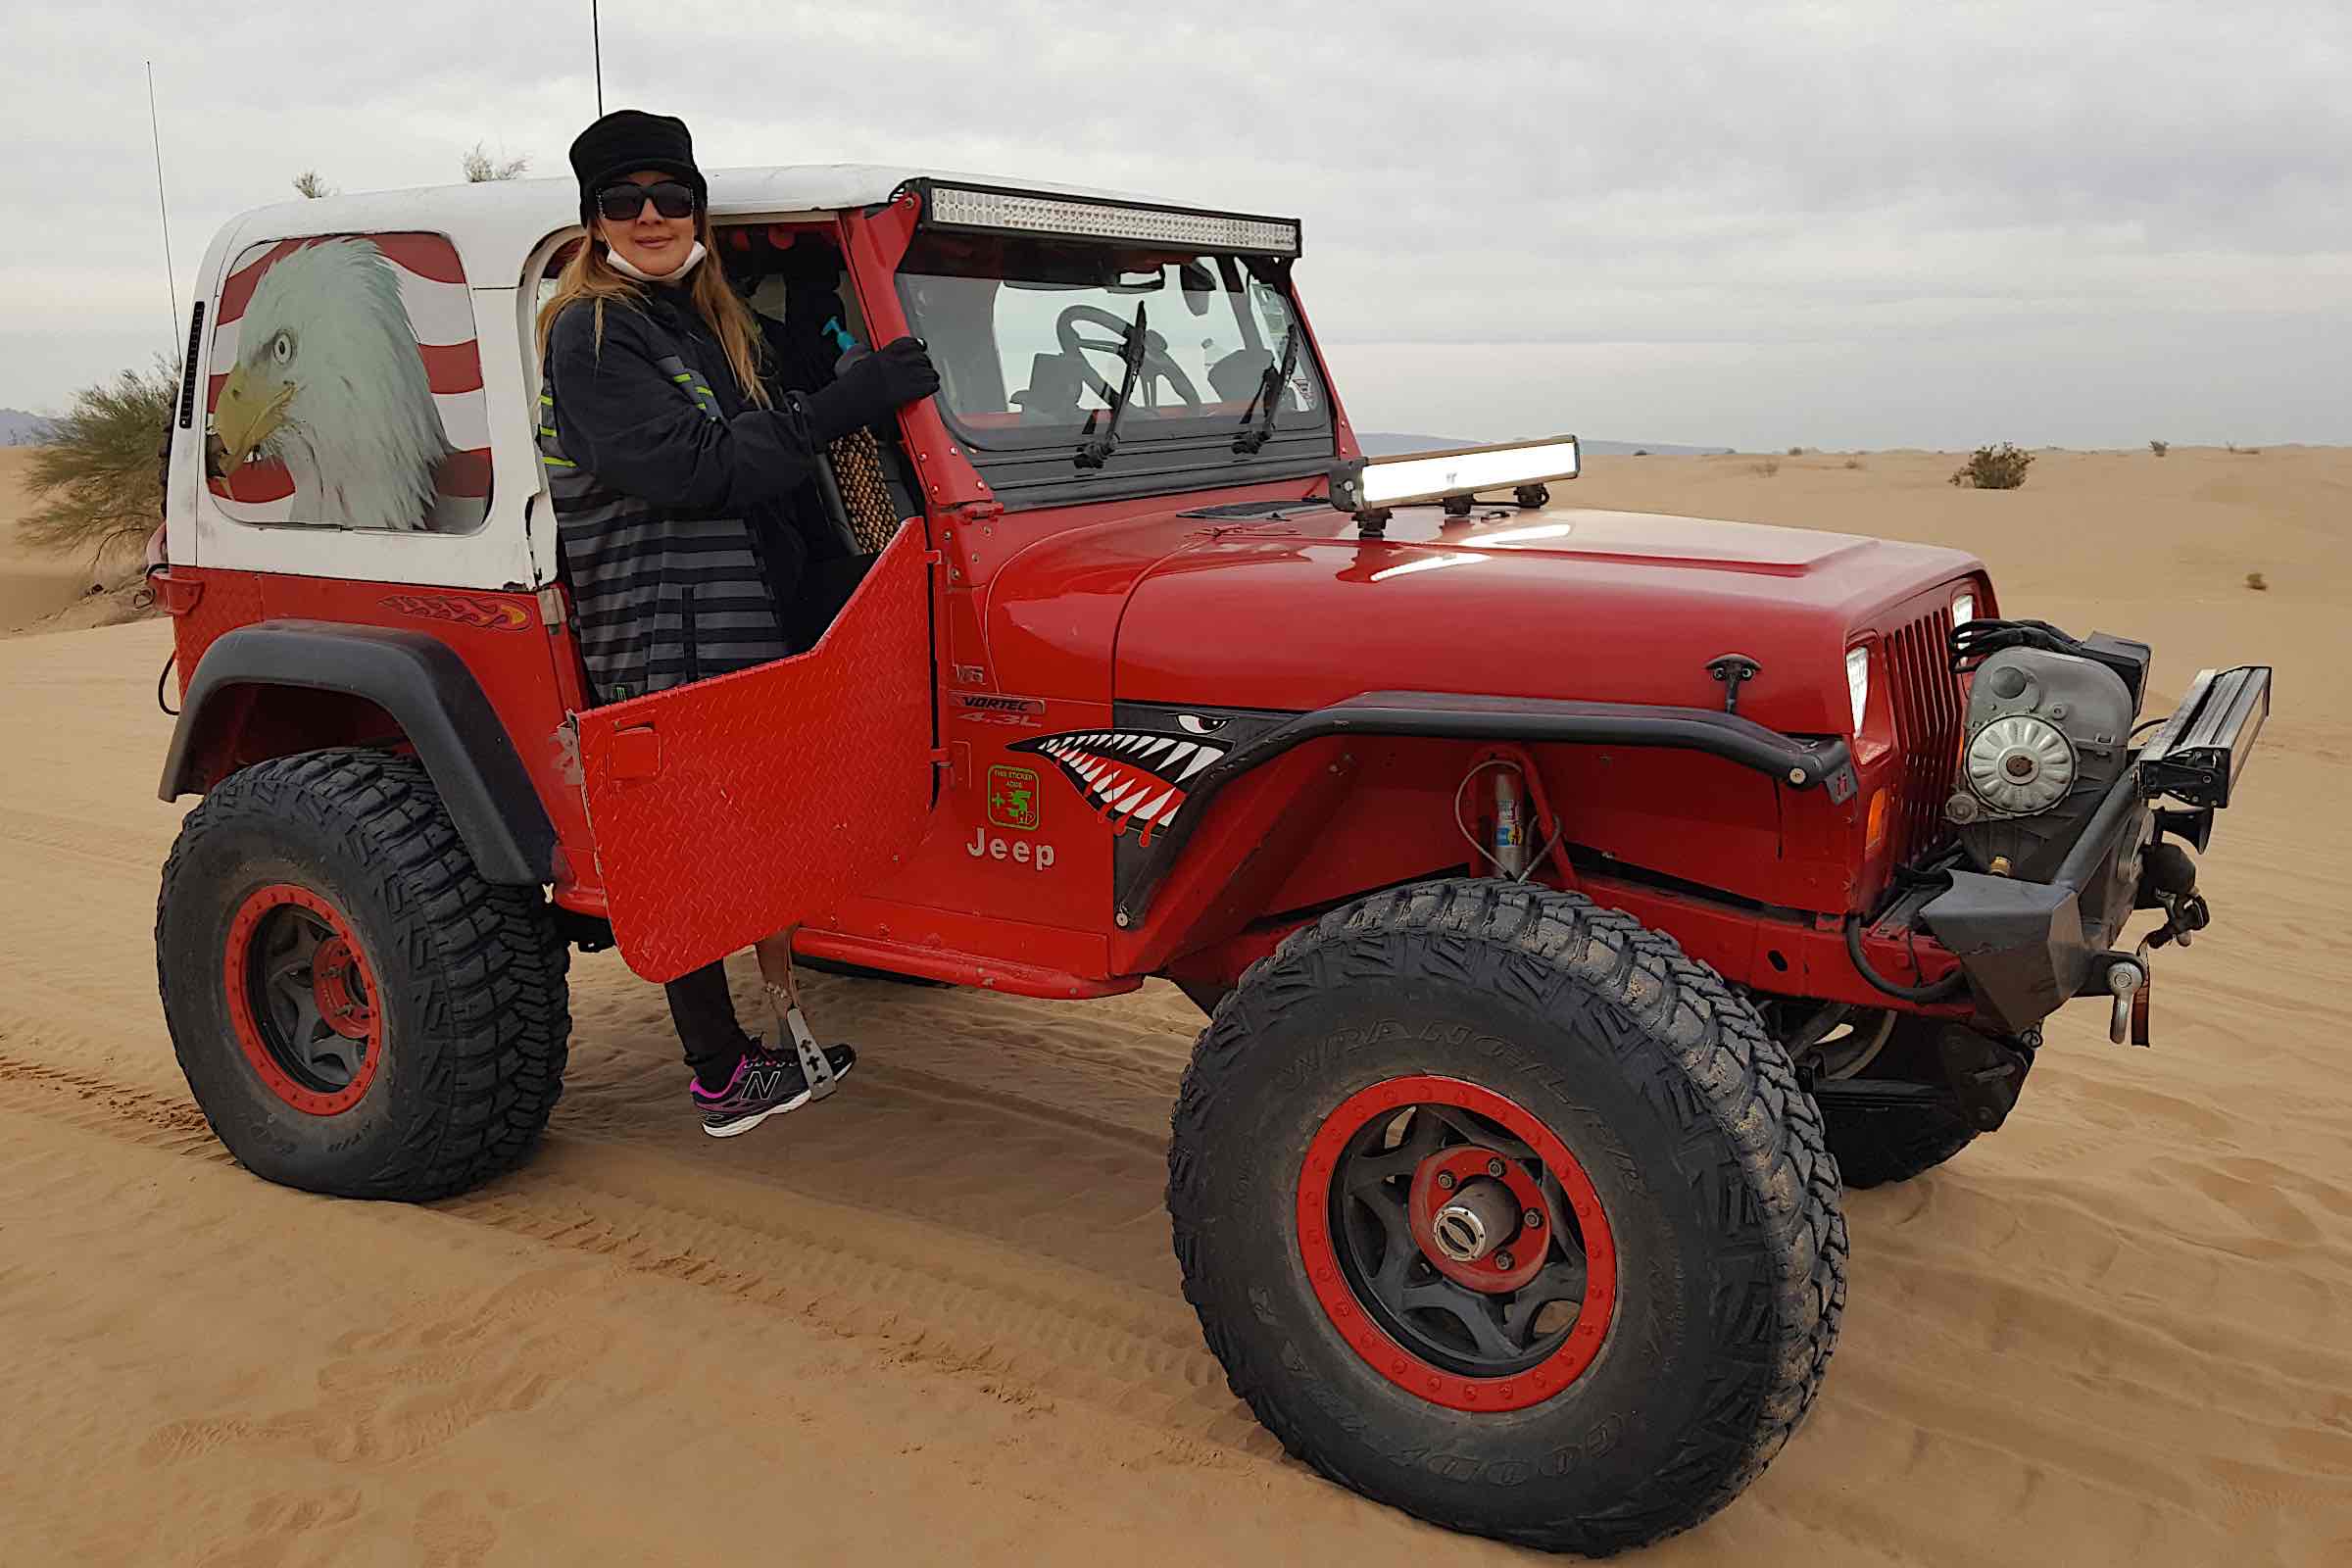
[{"left": 221, "top": 882, "right": 383, "bottom": 1116}]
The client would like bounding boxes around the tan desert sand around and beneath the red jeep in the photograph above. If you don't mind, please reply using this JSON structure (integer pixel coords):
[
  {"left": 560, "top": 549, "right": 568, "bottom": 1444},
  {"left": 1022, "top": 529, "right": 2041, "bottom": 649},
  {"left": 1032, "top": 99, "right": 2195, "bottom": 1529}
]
[{"left": 0, "top": 449, "right": 2352, "bottom": 1568}]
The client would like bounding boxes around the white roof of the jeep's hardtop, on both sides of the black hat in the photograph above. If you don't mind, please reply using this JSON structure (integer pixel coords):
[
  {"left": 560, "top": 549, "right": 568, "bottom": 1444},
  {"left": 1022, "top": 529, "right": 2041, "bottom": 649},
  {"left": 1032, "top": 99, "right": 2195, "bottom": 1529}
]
[{"left": 217, "top": 163, "right": 1171, "bottom": 289}]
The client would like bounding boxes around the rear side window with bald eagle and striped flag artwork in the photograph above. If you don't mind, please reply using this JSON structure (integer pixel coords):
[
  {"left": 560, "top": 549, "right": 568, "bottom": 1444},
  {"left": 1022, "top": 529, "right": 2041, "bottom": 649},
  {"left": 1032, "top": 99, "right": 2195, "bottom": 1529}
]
[{"left": 205, "top": 232, "right": 489, "bottom": 534}]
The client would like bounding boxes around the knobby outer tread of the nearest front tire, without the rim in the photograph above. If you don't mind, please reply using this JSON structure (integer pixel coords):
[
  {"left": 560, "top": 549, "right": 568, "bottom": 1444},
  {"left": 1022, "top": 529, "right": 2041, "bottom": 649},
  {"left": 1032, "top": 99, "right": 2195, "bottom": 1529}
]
[{"left": 1169, "top": 879, "right": 1846, "bottom": 1556}]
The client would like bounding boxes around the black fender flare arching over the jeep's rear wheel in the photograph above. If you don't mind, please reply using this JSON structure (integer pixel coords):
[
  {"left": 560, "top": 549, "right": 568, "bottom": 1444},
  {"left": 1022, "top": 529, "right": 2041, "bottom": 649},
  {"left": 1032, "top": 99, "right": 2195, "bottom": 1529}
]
[{"left": 155, "top": 620, "right": 555, "bottom": 886}]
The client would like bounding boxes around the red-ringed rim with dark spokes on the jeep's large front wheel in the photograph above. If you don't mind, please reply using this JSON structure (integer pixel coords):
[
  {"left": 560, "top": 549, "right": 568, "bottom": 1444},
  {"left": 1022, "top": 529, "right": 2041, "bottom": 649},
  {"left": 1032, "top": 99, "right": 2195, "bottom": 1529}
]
[{"left": 1298, "top": 1077, "right": 1618, "bottom": 1410}]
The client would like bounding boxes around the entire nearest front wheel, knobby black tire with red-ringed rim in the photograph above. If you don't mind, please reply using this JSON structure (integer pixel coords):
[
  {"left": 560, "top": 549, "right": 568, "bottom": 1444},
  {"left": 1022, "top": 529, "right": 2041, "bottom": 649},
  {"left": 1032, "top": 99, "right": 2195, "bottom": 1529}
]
[{"left": 1169, "top": 879, "right": 1846, "bottom": 1554}]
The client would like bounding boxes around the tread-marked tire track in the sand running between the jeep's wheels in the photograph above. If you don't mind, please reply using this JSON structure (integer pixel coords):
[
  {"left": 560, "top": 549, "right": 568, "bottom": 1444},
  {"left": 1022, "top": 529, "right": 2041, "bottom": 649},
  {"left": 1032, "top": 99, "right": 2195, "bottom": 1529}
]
[{"left": 0, "top": 1051, "right": 1280, "bottom": 1457}]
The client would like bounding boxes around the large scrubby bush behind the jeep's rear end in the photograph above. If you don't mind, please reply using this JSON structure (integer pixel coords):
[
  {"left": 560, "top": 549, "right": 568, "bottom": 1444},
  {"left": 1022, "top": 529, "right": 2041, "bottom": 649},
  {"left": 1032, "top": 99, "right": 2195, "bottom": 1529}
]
[{"left": 17, "top": 360, "right": 178, "bottom": 560}]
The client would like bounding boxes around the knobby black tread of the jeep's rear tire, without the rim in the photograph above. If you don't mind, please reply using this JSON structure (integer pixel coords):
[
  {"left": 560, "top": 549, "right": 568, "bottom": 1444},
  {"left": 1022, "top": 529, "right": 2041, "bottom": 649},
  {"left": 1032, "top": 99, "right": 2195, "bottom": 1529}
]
[{"left": 155, "top": 748, "right": 571, "bottom": 1201}]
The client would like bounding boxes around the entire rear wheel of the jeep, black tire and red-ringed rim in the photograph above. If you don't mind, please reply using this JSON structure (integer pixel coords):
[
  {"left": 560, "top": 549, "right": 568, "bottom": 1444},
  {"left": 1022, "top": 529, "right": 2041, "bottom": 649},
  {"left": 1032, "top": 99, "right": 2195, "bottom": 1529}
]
[{"left": 155, "top": 750, "right": 571, "bottom": 1199}]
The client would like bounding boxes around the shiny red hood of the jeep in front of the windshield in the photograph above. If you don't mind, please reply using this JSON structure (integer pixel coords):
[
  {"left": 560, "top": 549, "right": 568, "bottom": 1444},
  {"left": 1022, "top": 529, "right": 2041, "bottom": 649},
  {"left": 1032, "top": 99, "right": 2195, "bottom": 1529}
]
[{"left": 1115, "top": 508, "right": 1983, "bottom": 733}]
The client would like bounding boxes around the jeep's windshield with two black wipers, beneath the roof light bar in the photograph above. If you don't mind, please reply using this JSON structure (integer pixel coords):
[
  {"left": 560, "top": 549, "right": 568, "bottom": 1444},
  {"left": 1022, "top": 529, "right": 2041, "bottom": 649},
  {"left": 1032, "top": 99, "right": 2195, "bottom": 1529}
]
[{"left": 899, "top": 232, "right": 1331, "bottom": 493}]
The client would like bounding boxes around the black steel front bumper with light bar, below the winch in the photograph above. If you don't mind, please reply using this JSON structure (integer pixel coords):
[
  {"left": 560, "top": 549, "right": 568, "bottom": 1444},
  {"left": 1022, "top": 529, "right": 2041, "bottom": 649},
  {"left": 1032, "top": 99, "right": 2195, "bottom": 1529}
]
[{"left": 1919, "top": 665, "right": 2270, "bottom": 1034}]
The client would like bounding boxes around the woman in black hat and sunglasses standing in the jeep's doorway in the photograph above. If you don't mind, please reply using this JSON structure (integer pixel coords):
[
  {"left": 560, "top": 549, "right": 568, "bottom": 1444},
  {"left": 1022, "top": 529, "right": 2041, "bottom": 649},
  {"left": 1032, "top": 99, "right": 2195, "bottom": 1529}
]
[{"left": 539, "top": 108, "right": 939, "bottom": 1138}]
